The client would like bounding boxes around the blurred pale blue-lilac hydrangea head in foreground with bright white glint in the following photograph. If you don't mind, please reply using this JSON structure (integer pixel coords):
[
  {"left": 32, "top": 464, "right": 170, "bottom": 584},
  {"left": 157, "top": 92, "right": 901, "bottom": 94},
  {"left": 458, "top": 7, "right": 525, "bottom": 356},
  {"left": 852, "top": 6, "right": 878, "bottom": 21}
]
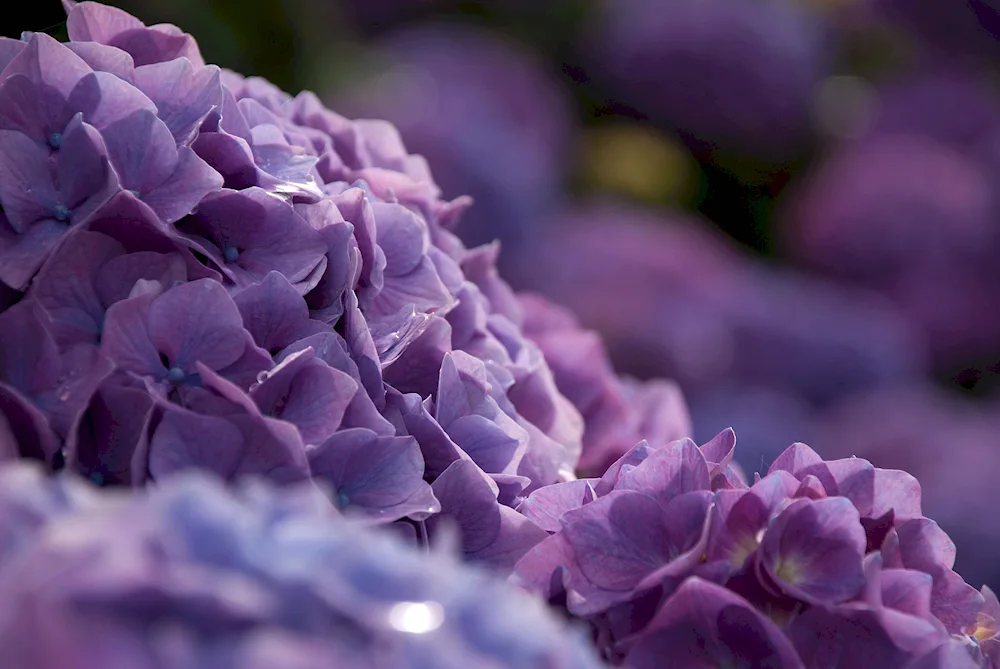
[{"left": 0, "top": 465, "right": 600, "bottom": 669}]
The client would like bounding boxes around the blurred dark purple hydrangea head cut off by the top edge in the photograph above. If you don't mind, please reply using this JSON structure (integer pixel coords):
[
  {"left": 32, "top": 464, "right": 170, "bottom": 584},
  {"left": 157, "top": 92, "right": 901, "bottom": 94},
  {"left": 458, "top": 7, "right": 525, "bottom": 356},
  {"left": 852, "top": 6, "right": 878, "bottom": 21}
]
[{"left": 594, "top": 0, "right": 828, "bottom": 159}]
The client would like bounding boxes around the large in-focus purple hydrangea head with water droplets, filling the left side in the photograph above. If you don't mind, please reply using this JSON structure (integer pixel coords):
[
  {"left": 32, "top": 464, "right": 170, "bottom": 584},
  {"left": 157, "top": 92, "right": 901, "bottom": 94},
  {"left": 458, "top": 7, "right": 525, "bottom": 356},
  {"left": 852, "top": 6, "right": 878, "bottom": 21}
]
[{"left": 0, "top": 0, "right": 596, "bottom": 569}]
